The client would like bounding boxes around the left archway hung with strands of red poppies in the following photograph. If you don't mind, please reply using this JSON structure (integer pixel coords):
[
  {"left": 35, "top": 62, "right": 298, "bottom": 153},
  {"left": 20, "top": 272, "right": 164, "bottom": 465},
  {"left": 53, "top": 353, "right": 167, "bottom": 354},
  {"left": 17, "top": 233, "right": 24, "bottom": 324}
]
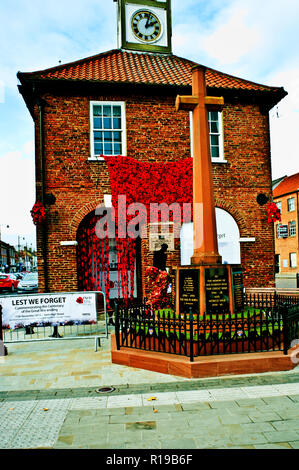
[{"left": 77, "top": 211, "right": 141, "bottom": 299}]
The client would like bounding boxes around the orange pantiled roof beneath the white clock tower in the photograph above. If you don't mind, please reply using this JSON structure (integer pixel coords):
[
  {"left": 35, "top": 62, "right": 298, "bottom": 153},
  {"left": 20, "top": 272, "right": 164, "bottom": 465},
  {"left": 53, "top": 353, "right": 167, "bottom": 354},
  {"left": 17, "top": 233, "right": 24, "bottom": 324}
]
[{"left": 18, "top": 49, "right": 286, "bottom": 99}]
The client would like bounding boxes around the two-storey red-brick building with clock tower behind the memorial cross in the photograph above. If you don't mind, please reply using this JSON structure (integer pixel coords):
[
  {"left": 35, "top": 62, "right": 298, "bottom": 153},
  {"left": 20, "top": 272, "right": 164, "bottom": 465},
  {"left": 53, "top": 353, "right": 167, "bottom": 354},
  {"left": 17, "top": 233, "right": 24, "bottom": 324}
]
[{"left": 18, "top": 0, "right": 286, "bottom": 302}]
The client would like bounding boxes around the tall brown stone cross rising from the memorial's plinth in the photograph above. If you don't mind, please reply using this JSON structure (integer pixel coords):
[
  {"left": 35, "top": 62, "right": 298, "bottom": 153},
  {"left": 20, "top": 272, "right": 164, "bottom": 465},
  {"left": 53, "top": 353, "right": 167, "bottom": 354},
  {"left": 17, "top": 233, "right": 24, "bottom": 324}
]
[{"left": 176, "top": 65, "right": 224, "bottom": 265}]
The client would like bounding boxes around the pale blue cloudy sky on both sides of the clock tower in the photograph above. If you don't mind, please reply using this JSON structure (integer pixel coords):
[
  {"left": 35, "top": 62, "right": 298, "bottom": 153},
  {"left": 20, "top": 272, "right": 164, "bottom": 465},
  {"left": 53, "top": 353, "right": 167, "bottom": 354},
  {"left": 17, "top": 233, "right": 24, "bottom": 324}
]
[{"left": 0, "top": 0, "right": 299, "bottom": 248}]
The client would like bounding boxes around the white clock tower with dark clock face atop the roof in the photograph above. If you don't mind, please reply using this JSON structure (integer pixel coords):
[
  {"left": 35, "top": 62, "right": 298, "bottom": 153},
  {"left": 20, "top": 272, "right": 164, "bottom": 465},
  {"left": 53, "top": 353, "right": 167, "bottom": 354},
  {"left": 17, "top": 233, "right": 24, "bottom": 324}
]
[{"left": 118, "top": 0, "right": 172, "bottom": 54}]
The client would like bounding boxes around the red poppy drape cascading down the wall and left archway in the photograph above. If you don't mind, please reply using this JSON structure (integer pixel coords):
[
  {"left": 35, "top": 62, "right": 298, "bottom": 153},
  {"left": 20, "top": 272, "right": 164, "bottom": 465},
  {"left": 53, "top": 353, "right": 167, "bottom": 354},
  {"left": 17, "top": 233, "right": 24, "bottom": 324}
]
[{"left": 77, "top": 156, "right": 193, "bottom": 303}]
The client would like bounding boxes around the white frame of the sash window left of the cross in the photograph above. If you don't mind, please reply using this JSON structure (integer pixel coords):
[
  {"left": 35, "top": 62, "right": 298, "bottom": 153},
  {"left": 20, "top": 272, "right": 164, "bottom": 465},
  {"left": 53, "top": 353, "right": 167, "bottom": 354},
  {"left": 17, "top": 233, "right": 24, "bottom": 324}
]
[{"left": 88, "top": 100, "right": 127, "bottom": 161}]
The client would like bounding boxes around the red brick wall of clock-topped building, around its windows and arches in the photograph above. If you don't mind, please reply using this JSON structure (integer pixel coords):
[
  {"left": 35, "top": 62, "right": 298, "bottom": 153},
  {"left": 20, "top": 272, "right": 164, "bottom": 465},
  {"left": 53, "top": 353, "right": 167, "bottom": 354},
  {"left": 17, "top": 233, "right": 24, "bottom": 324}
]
[{"left": 36, "top": 90, "right": 274, "bottom": 291}]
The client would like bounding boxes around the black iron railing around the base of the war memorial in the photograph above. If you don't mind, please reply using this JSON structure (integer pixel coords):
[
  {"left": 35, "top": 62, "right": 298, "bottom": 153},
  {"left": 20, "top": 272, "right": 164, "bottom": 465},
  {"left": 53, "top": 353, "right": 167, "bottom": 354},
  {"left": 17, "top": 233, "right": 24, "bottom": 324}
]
[{"left": 115, "top": 295, "right": 299, "bottom": 361}]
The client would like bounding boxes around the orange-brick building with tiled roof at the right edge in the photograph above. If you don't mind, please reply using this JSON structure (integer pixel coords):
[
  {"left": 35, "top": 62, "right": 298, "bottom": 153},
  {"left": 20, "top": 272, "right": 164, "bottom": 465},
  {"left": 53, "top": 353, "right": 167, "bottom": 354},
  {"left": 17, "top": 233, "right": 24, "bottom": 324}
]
[{"left": 273, "top": 173, "right": 299, "bottom": 288}]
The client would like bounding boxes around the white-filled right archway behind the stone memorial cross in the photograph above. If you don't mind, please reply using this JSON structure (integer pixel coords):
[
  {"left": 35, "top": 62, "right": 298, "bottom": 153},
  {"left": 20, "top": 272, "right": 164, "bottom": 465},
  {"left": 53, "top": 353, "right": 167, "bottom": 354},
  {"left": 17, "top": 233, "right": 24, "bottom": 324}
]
[{"left": 180, "top": 207, "right": 241, "bottom": 266}]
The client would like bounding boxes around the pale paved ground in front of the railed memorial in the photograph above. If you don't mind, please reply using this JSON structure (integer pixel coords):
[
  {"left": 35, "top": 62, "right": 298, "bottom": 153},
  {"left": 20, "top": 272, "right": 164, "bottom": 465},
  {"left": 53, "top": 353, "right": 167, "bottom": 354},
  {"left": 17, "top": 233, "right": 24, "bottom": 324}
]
[{"left": 0, "top": 337, "right": 299, "bottom": 451}]
